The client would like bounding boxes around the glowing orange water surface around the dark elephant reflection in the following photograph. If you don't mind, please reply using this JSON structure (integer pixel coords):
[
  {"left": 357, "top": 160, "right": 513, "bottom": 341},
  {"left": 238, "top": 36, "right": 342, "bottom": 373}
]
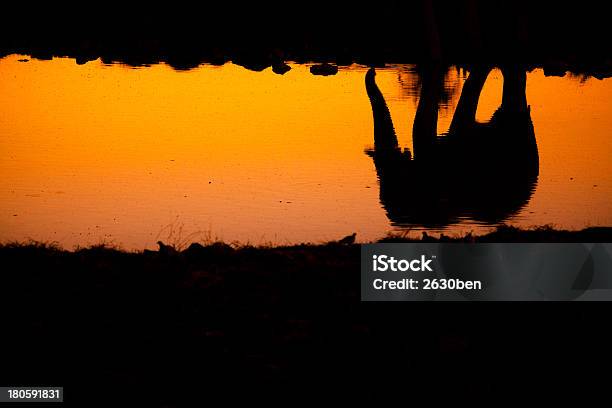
[{"left": 0, "top": 56, "right": 612, "bottom": 248}]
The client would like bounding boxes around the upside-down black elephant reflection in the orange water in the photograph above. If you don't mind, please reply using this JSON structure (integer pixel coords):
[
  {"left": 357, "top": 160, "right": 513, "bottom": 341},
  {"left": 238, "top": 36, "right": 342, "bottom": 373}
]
[{"left": 366, "top": 66, "right": 539, "bottom": 228}]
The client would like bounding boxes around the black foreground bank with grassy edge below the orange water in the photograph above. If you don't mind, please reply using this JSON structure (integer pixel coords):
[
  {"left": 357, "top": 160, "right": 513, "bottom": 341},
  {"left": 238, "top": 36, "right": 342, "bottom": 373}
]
[{"left": 0, "top": 228, "right": 612, "bottom": 406}]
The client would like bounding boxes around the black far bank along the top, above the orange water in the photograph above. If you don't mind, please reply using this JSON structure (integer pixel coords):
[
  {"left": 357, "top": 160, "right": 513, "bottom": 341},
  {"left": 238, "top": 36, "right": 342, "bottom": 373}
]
[{"left": 0, "top": 0, "right": 612, "bottom": 78}]
